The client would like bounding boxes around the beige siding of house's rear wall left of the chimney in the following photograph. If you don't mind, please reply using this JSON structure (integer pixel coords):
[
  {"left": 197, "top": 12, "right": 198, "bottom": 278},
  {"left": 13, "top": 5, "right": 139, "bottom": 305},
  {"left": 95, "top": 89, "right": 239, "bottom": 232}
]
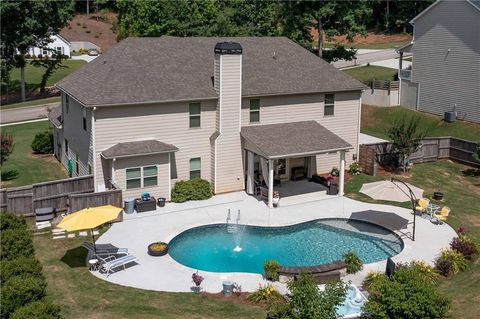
[{"left": 95, "top": 100, "right": 216, "bottom": 190}]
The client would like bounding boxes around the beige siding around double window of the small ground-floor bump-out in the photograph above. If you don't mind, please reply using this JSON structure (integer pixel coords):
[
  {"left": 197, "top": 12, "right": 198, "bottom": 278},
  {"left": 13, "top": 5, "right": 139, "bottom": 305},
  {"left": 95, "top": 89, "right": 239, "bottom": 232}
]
[{"left": 114, "top": 154, "right": 170, "bottom": 200}]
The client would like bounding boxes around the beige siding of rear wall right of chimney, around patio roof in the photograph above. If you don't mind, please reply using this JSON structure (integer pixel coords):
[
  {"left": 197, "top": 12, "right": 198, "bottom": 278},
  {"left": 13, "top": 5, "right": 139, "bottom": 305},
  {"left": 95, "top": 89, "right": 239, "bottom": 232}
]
[{"left": 242, "top": 91, "right": 361, "bottom": 173}]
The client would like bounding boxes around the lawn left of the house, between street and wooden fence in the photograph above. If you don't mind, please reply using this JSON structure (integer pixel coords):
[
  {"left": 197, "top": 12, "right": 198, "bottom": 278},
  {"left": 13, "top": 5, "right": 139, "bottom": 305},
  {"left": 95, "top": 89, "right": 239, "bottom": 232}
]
[{"left": 2, "top": 121, "right": 68, "bottom": 187}]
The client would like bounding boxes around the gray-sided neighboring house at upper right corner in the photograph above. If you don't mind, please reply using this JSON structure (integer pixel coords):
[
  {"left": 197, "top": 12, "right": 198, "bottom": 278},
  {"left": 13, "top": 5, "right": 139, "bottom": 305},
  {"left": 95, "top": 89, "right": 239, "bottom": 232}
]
[{"left": 398, "top": 0, "right": 480, "bottom": 122}]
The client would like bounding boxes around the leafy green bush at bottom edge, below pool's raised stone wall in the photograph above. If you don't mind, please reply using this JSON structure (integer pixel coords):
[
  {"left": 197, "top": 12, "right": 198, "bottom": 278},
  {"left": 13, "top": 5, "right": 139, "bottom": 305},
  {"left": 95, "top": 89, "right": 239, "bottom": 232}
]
[{"left": 270, "top": 274, "right": 347, "bottom": 319}]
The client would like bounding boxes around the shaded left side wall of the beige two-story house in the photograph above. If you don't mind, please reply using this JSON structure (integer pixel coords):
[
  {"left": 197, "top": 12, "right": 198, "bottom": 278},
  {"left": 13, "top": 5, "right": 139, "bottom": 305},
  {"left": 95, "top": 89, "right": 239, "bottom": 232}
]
[{"left": 58, "top": 93, "right": 93, "bottom": 176}]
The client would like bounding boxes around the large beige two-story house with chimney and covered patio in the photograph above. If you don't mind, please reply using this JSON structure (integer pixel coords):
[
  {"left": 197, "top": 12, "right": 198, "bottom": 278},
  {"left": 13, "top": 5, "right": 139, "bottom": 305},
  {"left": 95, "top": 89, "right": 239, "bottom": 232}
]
[{"left": 51, "top": 37, "right": 365, "bottom": 205}]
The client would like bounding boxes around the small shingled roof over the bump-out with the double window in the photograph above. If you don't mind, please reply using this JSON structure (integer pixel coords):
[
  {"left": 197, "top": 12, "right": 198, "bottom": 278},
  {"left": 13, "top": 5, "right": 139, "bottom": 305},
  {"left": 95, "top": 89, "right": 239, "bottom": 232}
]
[{"left": 102, "top": 140, "right": 178, "bottom": 159}]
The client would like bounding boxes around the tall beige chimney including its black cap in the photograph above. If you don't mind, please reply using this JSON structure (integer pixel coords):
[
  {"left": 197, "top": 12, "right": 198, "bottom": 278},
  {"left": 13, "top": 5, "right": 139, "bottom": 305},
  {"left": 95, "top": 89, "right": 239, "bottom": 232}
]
[{"left": 212, "top": 42, "right": 244, "bottom": 193}]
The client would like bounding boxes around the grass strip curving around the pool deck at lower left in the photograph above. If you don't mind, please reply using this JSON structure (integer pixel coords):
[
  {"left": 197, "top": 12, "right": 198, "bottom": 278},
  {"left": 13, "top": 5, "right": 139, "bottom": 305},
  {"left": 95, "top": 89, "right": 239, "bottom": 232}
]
[{"left": 34, "top": 234, "right": 266, "bottom": 319}]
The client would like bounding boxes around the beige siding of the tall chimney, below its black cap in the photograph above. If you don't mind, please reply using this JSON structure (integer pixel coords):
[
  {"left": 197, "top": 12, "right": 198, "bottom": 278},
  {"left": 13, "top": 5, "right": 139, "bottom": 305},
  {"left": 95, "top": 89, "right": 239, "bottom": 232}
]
[{"left": 215, "top": 55, "right": 244, "bottom": 193}]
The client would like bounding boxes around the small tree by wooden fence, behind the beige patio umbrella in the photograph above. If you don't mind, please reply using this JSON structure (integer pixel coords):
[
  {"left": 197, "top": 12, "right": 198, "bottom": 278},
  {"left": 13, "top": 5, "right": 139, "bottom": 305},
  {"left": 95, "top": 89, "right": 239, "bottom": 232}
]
[{"left": 388, "top": 116, "right": 426, "bottom": 172}]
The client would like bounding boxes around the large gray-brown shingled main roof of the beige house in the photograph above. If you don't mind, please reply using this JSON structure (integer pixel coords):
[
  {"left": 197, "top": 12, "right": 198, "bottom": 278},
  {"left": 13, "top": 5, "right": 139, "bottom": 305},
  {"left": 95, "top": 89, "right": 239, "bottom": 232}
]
[{"left": 57, "top": 37, "right": 365, "bottom": 106}]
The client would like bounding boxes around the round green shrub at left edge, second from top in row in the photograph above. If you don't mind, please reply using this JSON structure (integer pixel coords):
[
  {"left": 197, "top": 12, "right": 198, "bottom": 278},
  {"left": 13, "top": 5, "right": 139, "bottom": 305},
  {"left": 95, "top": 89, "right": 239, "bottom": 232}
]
[{"left": 0, "top": 229, "right": 34, "bottom": 261}]
